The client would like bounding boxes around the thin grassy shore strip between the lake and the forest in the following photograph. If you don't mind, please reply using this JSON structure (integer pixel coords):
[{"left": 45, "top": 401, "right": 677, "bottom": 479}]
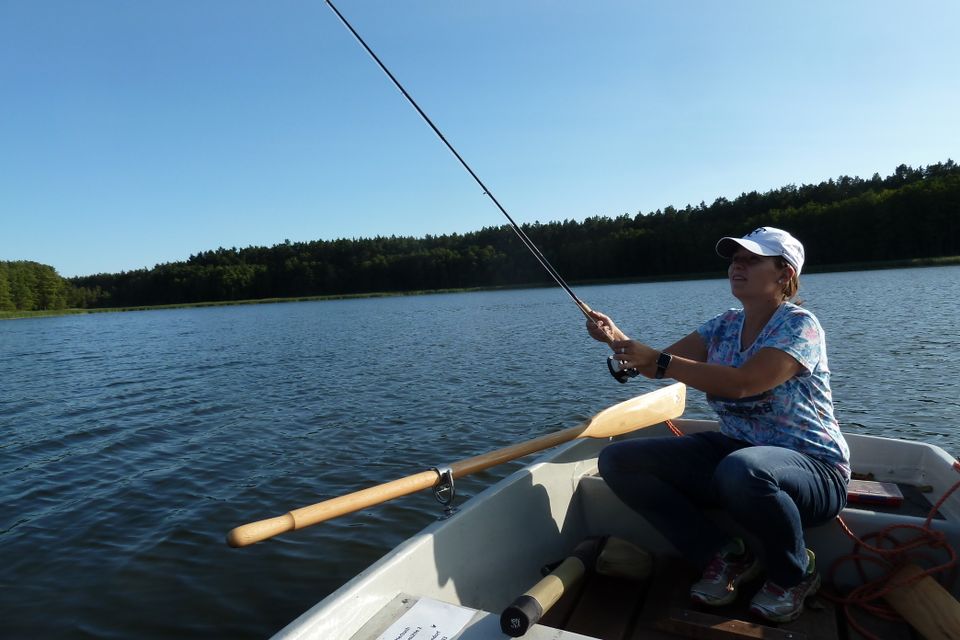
[{"left": 0, "top": 256, "right": 960, "bottom": 320}]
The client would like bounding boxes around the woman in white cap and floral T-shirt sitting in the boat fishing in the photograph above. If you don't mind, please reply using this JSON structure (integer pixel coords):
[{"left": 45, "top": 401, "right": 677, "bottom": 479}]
[{"left": 587, "top": 227, "right": 850, "bottom": 622}]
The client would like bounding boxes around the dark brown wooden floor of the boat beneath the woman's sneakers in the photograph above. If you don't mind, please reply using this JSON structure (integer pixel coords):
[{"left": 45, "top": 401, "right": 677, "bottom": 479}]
[{"left": 540, "top": 558, "right": 918, "bottom": 640}]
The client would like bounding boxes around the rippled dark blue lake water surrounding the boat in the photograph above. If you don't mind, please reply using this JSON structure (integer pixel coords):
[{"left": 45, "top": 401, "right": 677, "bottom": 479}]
[{"left": 0, "top": 267, "right": 960, "bottom": 638}]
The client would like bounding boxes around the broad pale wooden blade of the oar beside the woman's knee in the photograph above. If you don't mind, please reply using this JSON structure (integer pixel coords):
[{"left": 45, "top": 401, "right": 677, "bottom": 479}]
[{"left": 580, "top": 382, "right": 687, "bottom": 438}]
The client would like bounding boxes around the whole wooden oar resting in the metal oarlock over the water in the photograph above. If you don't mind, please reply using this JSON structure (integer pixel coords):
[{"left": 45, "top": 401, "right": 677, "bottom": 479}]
[{"left": 227, "top": 382, "right": 686, "bottom": 547}]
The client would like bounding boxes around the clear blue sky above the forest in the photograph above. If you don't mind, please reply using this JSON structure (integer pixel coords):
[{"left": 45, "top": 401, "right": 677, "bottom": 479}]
[{"left": 0, "top": 0, "right": 960, "bottom": 276}]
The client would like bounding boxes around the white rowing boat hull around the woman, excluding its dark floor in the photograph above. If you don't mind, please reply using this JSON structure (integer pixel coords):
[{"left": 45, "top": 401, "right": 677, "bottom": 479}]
[{"left": 277, "top": 419, "right": 960, "bottom": 640}]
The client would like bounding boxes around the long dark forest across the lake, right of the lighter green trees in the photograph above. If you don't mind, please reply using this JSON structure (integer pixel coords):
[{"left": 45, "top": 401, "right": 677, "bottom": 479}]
[{"left": 11, "top": 160, "right": 960, "bottom": 307}]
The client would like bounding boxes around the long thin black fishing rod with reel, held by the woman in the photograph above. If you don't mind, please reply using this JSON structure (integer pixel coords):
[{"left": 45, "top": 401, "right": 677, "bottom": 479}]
[{"left": 325, "top": 0, "right": 639, "bottom": 383}]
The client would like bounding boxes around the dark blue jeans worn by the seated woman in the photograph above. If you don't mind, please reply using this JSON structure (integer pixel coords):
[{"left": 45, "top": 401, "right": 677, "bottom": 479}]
[{"left": 599, "top": 432, "right": 847, "bottom": 588}]
